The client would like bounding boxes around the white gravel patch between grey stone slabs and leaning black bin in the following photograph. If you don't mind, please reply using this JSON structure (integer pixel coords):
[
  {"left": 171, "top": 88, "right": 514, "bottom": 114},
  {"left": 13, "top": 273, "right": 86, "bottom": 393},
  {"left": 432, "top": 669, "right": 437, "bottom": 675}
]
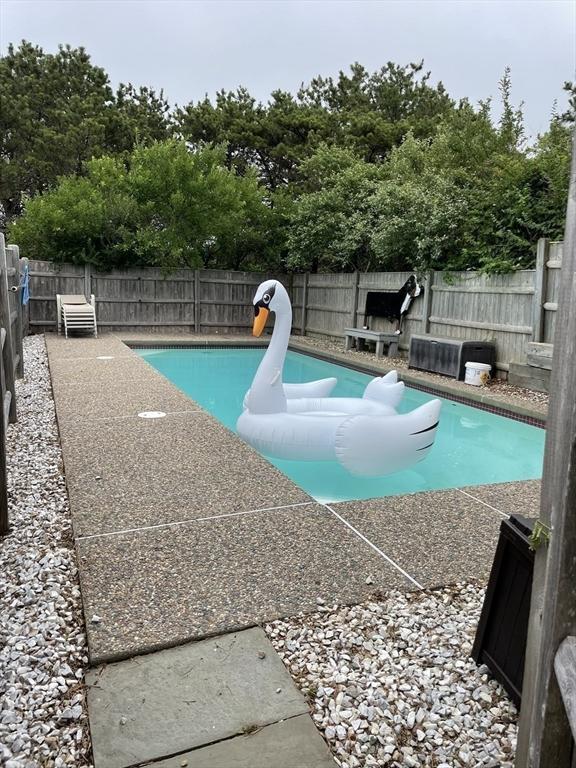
[{"left": 265, "top": 584, "right": 517, "bottom": 768}]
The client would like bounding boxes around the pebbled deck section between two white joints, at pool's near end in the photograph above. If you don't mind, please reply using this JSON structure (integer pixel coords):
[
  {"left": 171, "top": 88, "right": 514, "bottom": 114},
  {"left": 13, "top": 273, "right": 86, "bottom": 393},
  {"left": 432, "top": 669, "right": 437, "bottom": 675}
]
[{"left": 330, "top": 491, "right": 502, "bottom": 587}]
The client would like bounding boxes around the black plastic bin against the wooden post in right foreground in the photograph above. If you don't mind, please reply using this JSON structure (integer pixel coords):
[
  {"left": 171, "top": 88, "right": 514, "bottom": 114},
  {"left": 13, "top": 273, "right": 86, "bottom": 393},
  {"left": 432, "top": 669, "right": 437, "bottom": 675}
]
[{"left": 472, "top": 515, "right": 534, "bottom": 707}]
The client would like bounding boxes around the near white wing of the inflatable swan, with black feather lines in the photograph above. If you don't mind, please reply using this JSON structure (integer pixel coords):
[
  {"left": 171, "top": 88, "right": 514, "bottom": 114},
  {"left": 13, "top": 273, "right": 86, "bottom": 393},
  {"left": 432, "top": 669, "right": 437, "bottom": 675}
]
[{"left": 335, "top": 400, "right": 441, "bottom": 477}]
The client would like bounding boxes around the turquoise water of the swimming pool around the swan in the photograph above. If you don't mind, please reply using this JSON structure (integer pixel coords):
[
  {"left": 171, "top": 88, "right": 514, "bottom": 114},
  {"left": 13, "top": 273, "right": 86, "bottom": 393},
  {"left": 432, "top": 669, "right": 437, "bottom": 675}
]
[{"left": 138, "top": 348, "right": 545, "bottom": 502}]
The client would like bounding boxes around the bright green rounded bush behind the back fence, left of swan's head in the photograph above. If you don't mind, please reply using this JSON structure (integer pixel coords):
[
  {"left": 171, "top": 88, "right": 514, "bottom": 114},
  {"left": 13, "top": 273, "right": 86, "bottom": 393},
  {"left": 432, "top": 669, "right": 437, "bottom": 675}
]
[{"left": 10, "top": 140, "right": 281, "bottom": 269}]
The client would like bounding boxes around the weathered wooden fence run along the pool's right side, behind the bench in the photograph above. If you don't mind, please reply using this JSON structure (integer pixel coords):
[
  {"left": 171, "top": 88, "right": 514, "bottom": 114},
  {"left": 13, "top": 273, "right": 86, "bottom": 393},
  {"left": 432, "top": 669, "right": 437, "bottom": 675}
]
[{"left": 292, "top": 240, "right": 562, "bottom": 371}]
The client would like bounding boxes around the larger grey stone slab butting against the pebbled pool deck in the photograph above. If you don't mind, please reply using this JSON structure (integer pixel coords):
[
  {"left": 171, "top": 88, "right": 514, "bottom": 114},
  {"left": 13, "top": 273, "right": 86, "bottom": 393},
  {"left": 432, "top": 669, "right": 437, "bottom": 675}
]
[{"left": 86, "top": 629, "right": 308, "bottom": 768}]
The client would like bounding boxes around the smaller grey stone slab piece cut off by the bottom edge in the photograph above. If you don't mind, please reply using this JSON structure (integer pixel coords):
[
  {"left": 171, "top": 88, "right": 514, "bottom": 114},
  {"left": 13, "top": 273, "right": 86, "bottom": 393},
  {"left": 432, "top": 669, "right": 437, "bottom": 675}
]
[{"left": 152, "top": 715, "right": 336, "bottom": 768}]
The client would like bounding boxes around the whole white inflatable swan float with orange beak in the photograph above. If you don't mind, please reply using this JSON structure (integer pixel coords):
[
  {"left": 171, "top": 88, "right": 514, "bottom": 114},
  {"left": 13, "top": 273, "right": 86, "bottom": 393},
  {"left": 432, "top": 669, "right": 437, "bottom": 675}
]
[{"left": 237, "top": 280, "right": 440, "bottom": 477}]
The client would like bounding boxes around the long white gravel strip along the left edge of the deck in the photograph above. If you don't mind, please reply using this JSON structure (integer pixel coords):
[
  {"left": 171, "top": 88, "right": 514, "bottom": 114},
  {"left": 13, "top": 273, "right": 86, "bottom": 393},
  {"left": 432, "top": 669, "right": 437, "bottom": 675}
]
[{"left": 0, "top": 336, "right": 91, "bottom": 768}]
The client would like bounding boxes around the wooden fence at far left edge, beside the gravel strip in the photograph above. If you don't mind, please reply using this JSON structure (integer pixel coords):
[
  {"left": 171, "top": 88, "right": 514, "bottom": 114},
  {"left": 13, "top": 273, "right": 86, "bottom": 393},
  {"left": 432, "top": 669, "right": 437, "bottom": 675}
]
[{"left": 0, "top": 234, "right": 26, "bottom": 535}]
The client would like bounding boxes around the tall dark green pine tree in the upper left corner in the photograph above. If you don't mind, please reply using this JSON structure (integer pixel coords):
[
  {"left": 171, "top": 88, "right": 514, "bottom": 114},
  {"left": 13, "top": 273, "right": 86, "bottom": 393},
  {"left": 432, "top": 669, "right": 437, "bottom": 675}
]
[{"left": 0, "top": 41, "right": 168, "bottom": 225}]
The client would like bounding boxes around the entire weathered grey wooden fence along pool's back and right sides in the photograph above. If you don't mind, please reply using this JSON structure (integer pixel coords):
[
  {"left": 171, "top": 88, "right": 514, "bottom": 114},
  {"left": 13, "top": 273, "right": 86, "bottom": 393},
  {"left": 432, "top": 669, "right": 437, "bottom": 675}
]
[{"left": 24, "top": 240, "right": 562, "bottom": 371}]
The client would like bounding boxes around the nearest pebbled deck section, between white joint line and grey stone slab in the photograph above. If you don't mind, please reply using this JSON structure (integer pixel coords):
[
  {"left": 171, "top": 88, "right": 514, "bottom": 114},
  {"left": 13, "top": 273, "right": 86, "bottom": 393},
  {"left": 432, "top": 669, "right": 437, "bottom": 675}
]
[{"left": 77, "top": 503, "right": 413, "bottom": 663}]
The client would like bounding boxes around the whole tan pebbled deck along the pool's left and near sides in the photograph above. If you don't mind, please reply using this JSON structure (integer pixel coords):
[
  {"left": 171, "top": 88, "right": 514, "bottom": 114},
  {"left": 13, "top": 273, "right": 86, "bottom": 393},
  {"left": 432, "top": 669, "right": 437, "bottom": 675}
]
[{"left": 46, "top": 334, "right": 540, "bottom": 766}]
